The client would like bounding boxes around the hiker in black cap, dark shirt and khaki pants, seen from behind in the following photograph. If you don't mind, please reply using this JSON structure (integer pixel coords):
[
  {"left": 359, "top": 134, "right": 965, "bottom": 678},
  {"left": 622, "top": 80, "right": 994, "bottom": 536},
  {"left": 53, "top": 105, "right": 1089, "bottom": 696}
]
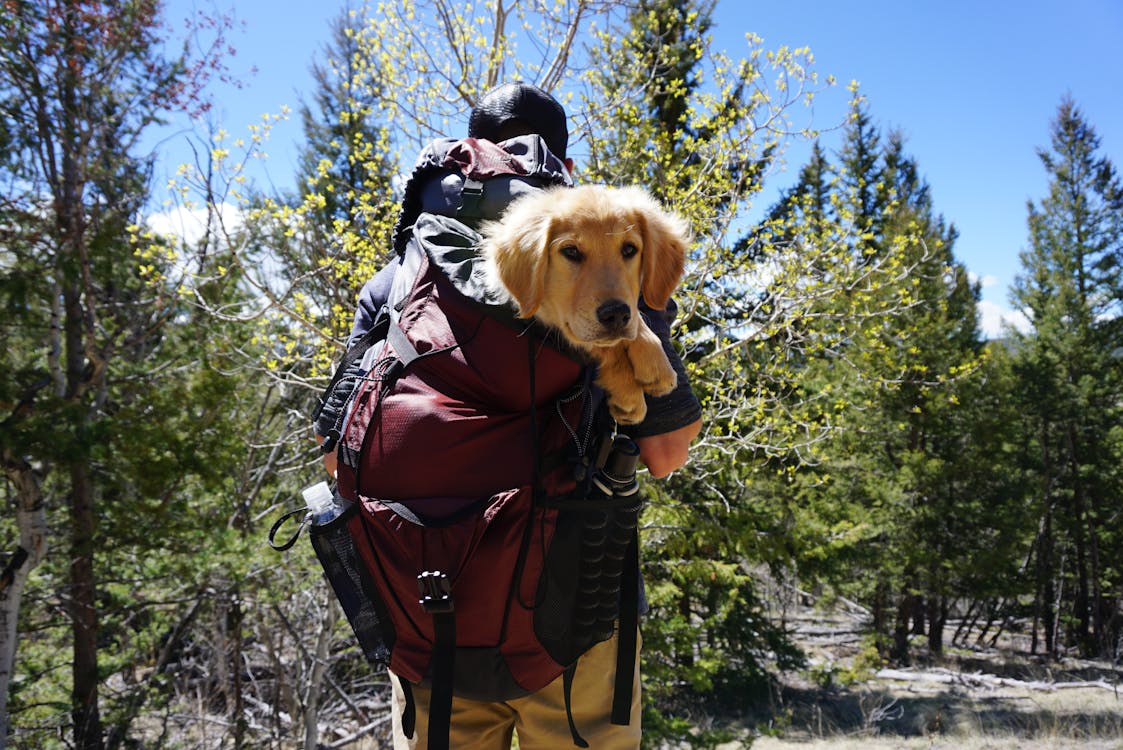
[{"left": 316, "top": 83, "right": 701, "bottom": 750}]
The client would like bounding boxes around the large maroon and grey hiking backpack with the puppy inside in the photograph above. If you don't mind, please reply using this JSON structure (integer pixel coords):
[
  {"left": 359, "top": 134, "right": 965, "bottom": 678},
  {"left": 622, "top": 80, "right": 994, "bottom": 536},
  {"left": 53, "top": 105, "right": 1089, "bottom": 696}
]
[{"left": 311, "top": 137, "right": 640, "bottom": 748}]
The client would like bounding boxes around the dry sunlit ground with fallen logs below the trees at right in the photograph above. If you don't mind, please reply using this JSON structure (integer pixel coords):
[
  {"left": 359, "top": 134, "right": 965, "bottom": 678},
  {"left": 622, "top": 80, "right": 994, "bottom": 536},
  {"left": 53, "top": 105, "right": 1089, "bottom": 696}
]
[{"left": 700, "top": 592, "right": 1123, "bottom": 750}]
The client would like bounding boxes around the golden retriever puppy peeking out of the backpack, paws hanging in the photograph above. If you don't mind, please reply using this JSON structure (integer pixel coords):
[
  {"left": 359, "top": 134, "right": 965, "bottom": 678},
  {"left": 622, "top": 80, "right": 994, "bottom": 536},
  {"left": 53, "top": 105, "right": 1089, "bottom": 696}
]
[{"left": 482, "top": 185, "right": 690, "bottom": 424}]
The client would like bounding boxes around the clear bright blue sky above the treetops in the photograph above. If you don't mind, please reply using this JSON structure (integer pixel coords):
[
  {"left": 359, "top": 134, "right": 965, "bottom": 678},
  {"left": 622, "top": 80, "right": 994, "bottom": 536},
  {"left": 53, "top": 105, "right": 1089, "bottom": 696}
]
[{"left": 160, "top": 0, "right": 1123, "bottom": 333}]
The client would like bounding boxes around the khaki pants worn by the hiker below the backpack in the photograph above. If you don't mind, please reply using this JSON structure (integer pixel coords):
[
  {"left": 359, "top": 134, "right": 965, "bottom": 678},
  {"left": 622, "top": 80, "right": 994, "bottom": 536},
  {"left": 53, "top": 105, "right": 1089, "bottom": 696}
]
[{"left": 390, "top": 635, "right": 640, "bottom": 750}]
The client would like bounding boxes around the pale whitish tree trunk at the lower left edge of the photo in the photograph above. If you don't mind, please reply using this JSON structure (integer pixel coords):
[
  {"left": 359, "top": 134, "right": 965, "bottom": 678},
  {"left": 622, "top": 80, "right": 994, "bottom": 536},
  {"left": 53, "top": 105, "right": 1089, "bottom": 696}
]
[{"left": 0, "top": 449, "right": 47, "bottom": 750}]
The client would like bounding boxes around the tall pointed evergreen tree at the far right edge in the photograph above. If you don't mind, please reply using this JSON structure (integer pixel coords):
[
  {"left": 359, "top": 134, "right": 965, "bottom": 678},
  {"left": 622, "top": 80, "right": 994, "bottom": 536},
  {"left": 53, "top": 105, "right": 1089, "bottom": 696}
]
[{"left": 1013, "top": 99, "right": 1123, "bottom": 656}]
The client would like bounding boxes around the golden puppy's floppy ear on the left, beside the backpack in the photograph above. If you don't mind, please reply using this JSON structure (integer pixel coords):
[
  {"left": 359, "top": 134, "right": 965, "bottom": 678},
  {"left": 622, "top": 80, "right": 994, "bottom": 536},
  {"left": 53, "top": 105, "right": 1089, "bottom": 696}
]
[{"left": 486, "top": 201, "right": 551, "bottom": 318}]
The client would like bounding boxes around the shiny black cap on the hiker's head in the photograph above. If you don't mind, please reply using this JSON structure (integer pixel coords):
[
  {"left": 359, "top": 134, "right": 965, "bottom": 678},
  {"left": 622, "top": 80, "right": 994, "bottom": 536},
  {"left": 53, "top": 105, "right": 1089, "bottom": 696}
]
[{"left": 468, "top": 83, "right": 569, "bottom": 159}]
